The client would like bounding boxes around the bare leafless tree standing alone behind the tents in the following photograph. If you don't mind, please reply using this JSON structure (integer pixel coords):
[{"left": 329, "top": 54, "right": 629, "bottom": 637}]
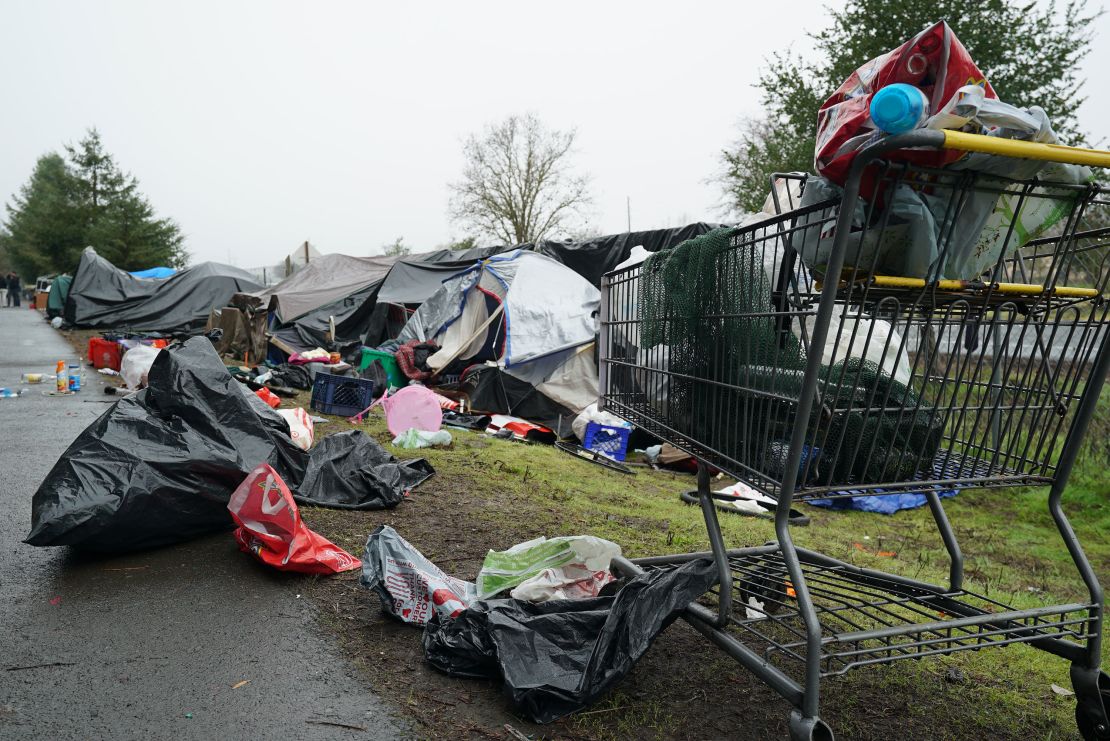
[{"left": 448, "top": 113, "right": 591, "bottom": 244}]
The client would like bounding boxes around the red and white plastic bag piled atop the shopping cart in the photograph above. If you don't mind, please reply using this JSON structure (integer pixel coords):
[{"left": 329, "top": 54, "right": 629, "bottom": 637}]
[{"left": 815, "top": 21, "right": 998, "bottom": 188}]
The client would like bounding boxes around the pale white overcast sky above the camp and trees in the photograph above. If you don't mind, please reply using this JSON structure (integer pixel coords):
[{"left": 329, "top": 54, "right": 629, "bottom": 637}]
[{"left": 0, "top": 0, "right": 1110, "bottom": 267}]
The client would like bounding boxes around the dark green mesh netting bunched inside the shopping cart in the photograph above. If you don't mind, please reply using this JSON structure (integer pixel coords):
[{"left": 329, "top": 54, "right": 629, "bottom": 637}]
[{"left": 638, "top": 227, "right": 941, "bottom": 485}]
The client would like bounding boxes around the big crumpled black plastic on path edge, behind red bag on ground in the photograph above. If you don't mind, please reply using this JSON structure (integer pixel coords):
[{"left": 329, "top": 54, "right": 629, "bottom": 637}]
[{"left": 26, "top": 337, "right": 432, "bottom": 551}]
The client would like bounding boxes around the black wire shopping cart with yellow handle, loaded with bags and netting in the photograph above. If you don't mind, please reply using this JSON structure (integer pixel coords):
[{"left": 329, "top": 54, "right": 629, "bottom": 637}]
[{"left": 601, "top": 131, "right": 1110, "bottom": 740}]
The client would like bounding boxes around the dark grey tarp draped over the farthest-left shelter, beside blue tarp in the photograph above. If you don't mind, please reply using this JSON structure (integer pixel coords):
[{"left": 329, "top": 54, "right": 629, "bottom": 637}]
[{"left": 64, "top": 247, "right": 261, "bottom": 333}]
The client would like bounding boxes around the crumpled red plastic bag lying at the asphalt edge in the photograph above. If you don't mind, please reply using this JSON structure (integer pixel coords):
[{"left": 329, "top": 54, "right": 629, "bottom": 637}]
[{"left": 228, "top": 464, "right": 362, "bottom": 573}]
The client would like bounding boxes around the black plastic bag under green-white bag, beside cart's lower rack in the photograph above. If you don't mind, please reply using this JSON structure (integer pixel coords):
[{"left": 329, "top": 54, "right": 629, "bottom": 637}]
[{"left": 424, "top": 559, "right": 717, "bottom": 723}]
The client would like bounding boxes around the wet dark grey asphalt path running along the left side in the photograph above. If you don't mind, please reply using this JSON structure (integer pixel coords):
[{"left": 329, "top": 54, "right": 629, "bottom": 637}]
[{"left": 0, "top": 308, "right": 407, "bottom": 739}]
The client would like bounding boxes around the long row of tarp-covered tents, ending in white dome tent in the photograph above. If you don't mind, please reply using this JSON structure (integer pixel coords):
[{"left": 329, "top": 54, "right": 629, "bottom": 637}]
[{"left": 51, "top": 223, "right": 716, "bottom": 426}]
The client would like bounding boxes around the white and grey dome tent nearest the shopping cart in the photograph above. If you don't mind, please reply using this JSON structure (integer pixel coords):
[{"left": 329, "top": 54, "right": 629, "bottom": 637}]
[{"left": 397, "top": 250, "right": 601, "bottom": 426}]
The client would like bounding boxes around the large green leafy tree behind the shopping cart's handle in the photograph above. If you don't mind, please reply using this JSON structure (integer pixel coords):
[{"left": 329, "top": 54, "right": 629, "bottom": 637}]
[{"left": 720, "top": 0, "right": 1101, "bottom": 212}]
